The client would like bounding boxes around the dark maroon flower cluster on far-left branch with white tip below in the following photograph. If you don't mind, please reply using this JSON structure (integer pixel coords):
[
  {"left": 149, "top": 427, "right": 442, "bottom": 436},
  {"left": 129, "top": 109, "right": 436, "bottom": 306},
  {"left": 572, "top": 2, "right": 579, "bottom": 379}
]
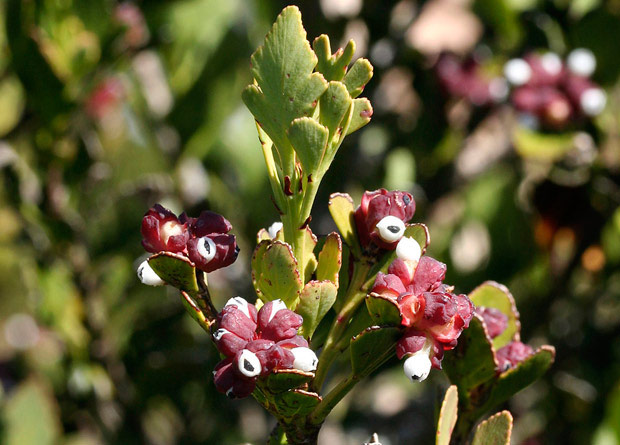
[{"left": 138, "top": 204, "right": 239, "bottom": 284}]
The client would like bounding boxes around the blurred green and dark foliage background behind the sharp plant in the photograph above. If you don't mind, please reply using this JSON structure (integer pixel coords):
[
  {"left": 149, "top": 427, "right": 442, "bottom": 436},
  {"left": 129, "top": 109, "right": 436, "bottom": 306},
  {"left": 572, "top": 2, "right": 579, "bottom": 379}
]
[{"left": 0, "top": 0, "right": 620, "bottom": 445}]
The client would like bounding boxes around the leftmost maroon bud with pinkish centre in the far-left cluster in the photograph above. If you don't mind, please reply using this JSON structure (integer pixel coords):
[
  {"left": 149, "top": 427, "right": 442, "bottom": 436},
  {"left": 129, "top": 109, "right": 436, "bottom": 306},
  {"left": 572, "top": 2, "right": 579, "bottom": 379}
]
[{"left": 142, "top": 204, "right": 189, "bottom": 253}]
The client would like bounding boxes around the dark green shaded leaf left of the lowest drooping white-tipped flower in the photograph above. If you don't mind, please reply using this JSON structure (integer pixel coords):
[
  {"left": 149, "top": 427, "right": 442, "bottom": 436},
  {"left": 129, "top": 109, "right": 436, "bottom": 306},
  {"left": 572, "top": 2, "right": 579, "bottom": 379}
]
[{"left": 351, "top": 326, "right": 401, "bottom": 377}]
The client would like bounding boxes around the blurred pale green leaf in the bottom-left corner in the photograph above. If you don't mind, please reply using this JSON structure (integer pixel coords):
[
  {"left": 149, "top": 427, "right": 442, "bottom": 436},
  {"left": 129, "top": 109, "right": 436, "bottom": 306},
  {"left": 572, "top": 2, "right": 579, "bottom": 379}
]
[{"left": 2, "top": 380, "right": 61, "bottom": 445}]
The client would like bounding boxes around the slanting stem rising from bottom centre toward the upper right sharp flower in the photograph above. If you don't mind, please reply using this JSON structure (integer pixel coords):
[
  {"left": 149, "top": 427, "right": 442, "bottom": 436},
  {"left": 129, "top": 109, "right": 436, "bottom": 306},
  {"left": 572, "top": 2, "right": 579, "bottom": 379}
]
[{"left": 313, "top": 261, "right": 371, "bottom": 390}]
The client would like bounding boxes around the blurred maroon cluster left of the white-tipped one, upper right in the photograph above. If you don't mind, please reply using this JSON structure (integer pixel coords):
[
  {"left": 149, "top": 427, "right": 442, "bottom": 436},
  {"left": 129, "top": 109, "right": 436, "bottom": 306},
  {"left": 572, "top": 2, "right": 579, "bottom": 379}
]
[{"left": 435, "top": 54, "right": 508, "bottom": 106}]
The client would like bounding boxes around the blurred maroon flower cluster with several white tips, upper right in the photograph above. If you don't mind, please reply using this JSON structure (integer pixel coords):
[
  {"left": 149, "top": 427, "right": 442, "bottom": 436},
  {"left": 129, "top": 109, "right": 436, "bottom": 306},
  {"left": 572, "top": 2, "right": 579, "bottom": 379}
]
[{"left": 504, "top": 48, "right": 607, "bottom": 129}]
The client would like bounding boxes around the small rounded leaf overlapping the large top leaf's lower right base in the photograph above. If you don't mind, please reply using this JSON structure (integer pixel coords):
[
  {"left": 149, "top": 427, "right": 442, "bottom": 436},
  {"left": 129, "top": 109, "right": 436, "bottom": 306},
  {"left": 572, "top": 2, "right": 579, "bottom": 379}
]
[{"left": 288, "top": 117, "right": 329, "bottom": 176}]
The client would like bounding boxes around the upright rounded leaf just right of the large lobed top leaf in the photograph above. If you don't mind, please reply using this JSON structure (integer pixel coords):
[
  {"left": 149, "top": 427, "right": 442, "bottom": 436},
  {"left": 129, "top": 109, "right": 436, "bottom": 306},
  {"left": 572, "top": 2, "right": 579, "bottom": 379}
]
[{"left": 319, "top": 81, "right": 353, "bottom": 142}]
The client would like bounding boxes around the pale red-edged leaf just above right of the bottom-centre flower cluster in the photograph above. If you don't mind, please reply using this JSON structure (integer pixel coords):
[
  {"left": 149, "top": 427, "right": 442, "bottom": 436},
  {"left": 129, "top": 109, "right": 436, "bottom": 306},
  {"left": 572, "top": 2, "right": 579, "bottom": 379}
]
[{"left": 295, "top": 281, "right": 338, "bottom": 338}]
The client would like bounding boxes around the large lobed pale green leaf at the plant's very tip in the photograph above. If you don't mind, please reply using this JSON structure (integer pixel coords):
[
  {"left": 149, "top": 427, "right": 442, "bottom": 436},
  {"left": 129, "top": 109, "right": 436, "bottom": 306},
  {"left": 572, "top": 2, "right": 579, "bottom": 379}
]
[{"left": 243, "top": 6, "right": 327, "bottom": 176}]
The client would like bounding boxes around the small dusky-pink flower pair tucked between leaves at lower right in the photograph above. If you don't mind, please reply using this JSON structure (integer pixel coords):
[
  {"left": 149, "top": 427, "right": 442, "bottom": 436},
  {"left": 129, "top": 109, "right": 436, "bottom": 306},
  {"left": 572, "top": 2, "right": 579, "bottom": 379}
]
[{"left": 476, "top": 306, "right": 534, "bottom": 372}]
